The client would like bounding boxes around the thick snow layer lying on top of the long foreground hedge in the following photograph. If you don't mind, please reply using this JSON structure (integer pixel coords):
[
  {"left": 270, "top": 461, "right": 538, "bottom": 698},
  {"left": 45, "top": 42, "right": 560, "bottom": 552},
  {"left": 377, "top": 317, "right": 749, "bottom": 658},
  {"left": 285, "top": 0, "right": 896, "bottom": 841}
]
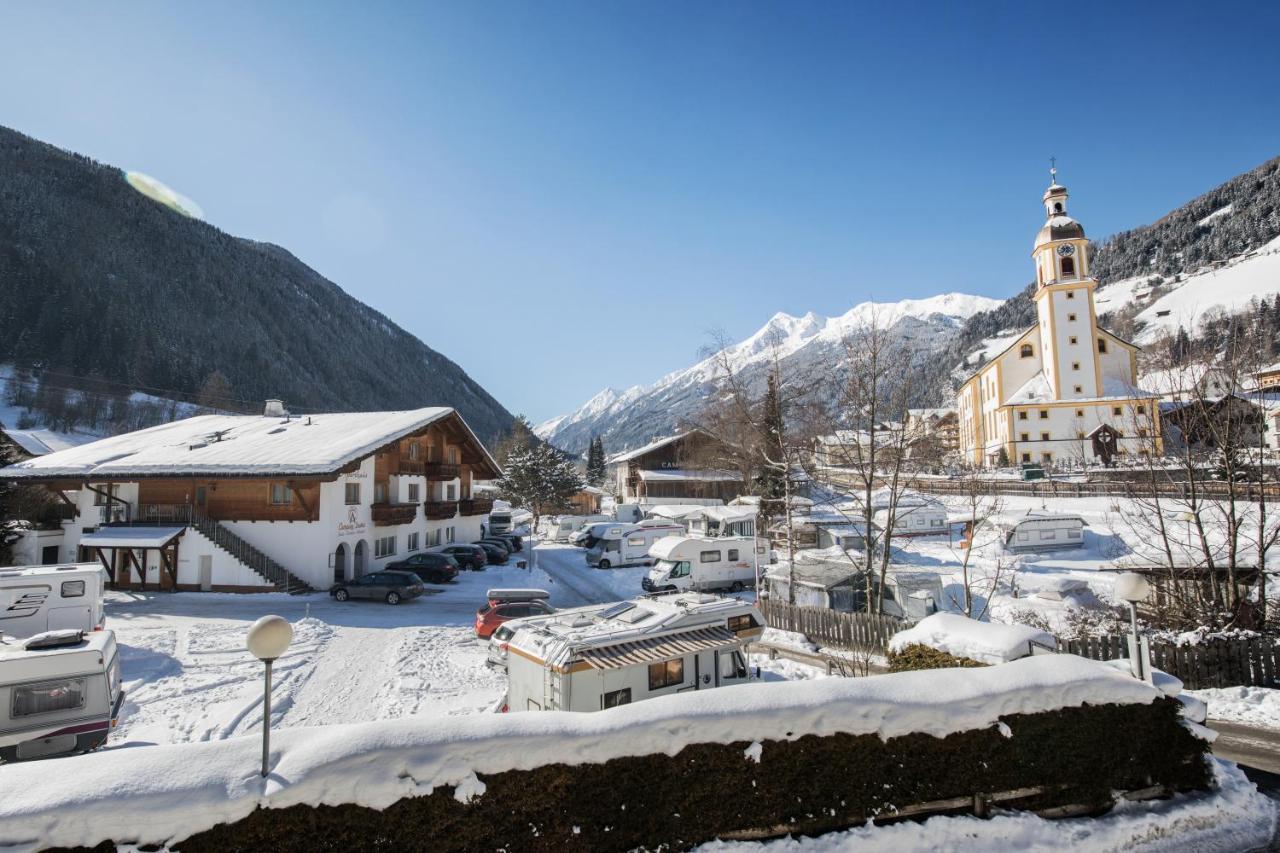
[{"left": 0, "top": 654, "right": 1161, "bottom": 850}]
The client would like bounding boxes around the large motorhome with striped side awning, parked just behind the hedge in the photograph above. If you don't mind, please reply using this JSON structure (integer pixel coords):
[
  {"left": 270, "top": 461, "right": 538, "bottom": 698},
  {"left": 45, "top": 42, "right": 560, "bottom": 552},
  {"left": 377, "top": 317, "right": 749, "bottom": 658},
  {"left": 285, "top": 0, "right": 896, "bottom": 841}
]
[{"left": 503, "top": 593, "right": 764, "bottom": 711}]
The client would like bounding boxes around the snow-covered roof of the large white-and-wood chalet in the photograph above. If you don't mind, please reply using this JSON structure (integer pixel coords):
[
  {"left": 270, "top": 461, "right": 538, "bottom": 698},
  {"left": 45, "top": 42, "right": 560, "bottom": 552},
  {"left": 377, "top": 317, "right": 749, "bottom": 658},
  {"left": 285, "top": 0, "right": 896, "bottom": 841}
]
[{"left": 0, "top": 406, "right": 500, "bottom": 480}]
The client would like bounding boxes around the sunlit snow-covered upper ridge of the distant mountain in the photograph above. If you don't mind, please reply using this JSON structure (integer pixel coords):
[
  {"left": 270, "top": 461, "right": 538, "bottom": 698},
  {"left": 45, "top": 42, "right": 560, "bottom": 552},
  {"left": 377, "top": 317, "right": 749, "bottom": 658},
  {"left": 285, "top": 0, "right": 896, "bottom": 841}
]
[{"left": 534, "top": 293, "right": 1001, "bottom": 455}]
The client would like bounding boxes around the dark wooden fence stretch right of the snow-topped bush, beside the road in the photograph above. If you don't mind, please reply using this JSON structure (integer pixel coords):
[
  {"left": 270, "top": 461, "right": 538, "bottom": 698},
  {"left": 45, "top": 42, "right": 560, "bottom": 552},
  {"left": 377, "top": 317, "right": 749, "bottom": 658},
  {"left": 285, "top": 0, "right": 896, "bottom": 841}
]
[{"left": 1059, "top": 634, "right": 1280, "bottom": 690}]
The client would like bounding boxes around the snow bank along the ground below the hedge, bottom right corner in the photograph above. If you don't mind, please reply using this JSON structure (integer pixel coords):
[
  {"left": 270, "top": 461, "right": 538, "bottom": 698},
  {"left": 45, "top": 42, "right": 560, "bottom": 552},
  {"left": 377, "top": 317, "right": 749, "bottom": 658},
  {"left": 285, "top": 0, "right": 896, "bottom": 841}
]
[{"left": 698, "top": 760, "right": 1277, "bottom": 853}]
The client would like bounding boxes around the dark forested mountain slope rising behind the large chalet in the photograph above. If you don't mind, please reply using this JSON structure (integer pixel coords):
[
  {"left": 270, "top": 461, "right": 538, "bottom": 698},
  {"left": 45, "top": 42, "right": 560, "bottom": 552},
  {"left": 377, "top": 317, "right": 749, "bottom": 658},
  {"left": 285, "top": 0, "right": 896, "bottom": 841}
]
[{"left": 0, "top": 128, "right": 512, "bottom": 442}]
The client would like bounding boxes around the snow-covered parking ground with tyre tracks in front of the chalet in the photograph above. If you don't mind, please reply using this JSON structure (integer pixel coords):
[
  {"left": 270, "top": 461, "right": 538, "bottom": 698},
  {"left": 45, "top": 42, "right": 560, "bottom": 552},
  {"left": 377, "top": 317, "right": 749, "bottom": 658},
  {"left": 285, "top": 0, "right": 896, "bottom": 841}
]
[{"left": 106, "top": 544, "right": 820, "bottom": 749}]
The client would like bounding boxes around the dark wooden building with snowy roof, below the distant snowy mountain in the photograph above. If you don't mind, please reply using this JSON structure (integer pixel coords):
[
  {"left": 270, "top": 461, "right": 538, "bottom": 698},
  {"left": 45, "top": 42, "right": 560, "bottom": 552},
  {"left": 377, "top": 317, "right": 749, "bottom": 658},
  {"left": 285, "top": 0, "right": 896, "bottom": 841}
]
[{"left": 608, "top": 429, "right": 748, "bottom": 503}]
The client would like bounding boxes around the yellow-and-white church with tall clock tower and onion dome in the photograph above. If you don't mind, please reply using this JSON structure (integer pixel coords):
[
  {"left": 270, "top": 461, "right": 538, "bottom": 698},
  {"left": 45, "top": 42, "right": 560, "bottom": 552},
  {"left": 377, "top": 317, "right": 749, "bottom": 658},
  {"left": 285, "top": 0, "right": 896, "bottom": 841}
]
[{"left": 956, "top": 169, "right": 1161, "bottom": 466}]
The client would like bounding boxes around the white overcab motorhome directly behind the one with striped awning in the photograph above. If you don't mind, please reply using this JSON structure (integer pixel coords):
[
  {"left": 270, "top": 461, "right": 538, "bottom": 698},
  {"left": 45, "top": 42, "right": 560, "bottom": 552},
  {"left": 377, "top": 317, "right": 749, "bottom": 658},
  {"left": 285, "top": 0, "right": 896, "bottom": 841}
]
[{"left": 640, "top": 537, "right": 768, "bottom": 592}]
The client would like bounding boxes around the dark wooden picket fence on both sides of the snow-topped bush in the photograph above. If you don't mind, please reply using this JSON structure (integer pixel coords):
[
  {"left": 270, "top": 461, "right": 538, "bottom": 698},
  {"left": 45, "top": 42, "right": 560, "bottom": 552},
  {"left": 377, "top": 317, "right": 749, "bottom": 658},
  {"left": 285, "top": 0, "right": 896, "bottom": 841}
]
[{"left": 760, "top": 598, "right": 1280, "bottom": 690}]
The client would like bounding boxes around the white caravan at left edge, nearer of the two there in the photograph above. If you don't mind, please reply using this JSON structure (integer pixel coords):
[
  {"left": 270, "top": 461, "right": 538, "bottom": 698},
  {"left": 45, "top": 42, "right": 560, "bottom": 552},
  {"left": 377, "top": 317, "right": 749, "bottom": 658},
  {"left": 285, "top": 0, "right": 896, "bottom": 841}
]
[{"left": 0, "top": 630, "right": 124, "bottom": 763}]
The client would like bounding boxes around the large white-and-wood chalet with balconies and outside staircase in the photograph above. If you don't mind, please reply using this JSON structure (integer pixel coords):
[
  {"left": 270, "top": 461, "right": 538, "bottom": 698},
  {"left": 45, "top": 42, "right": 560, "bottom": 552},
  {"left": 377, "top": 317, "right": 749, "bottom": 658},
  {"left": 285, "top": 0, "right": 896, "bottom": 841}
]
[{"left": 0, "top": 401, "right": 502, "bottom": 592}]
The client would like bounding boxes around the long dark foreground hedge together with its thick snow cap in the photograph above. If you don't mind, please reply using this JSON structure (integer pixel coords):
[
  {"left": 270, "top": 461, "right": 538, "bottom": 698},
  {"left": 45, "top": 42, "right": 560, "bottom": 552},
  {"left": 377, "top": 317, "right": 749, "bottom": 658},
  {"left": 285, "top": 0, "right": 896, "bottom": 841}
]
[{"left": 0, "top": 654, "right": 1208, "bottom": 850}]
